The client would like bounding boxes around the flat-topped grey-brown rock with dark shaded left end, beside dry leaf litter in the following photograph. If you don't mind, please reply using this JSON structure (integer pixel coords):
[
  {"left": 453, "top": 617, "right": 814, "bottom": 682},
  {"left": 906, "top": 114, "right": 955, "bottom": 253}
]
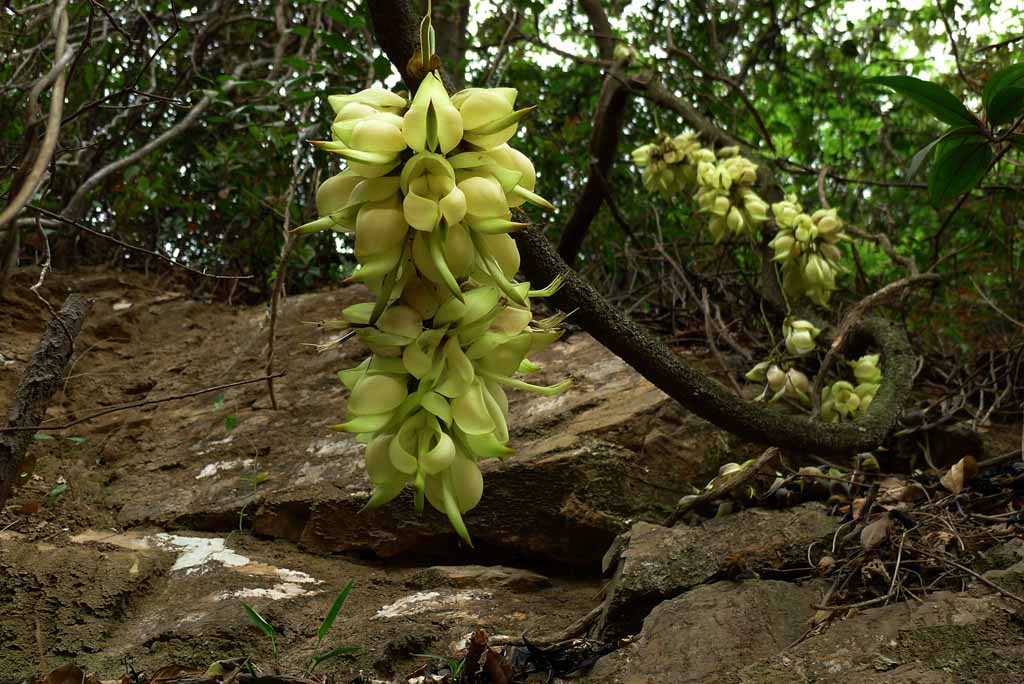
[{"left": 596, "top": 504, "right": 839, "bottom": 640}]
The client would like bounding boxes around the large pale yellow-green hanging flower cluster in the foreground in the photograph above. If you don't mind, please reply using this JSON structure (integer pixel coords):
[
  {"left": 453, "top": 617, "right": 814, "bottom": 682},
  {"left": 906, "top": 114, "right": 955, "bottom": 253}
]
[{"left": 298, "top": 73, "right": 569, "bottom": 543}]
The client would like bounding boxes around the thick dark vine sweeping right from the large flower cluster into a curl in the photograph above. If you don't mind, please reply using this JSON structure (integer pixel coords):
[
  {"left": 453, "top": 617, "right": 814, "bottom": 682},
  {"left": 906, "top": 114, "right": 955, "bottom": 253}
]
[{"left": 513, "top": 229, "right": 913, "bottom": 455}]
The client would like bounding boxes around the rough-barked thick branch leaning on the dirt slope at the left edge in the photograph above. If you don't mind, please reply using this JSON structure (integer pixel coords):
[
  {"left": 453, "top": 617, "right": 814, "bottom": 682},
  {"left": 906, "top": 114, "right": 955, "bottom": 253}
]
[{"left": 0, "top": 295, "right": 92, "bottom": 509}]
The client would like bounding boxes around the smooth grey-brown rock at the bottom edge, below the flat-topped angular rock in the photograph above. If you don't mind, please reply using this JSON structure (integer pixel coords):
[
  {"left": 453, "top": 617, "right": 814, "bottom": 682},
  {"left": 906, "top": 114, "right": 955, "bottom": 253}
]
[{"left": 586, "top": 580, "right": 820, "bottom": 684}]
